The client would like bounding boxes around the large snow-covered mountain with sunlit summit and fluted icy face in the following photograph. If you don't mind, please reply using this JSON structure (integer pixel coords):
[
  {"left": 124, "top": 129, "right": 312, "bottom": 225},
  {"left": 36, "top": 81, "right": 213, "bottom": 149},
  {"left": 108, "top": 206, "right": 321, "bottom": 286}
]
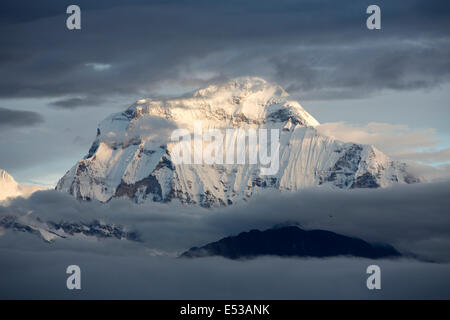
[{"left": 56, "top": 77, "right": 419, "bottom": 207}]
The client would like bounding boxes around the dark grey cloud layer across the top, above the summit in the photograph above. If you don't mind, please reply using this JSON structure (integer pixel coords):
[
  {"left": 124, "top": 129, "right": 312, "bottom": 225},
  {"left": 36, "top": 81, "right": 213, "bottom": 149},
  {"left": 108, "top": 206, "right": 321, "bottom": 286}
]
[{"left": 0, "top": 0, "right": 450, "bottom": 102}]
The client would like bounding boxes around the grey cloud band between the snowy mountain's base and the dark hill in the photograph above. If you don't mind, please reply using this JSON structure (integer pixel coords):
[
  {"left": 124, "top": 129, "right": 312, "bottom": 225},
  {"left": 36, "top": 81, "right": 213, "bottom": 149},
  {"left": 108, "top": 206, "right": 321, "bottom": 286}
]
[{"left": 0, "top": 181, "right": 450, "bottom": 261}]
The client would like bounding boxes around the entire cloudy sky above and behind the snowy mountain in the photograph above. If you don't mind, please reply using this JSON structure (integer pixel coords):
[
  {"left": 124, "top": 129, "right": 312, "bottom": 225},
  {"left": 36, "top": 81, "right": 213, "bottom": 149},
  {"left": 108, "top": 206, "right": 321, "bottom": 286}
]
[{"left": 0, "top": 0, "right": 450, "bottom": 185}]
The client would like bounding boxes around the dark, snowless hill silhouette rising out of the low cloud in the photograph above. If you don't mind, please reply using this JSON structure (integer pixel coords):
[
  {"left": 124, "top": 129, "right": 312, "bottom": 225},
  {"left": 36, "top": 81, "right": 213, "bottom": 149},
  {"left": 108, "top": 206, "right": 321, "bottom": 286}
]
[{"left": 181, "top": 226, "right": 400, "bottom": 259}]
